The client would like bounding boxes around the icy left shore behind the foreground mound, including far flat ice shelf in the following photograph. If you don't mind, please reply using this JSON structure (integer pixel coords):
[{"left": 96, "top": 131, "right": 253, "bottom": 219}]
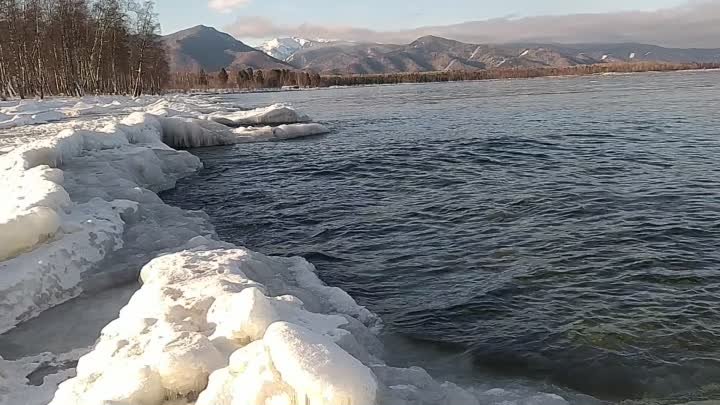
[{"left": 0, "top": 95, "right": 326, "bottom": 333}]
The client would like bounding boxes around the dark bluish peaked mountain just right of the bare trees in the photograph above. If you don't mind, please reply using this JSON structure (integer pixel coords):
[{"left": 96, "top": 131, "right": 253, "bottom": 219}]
[{"left": 162, "top": 25, "right": 292, "bottom": 72}]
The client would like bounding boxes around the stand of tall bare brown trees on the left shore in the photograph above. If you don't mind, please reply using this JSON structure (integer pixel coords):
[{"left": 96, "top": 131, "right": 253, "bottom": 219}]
[{"left": 0, "top": 0, "right": 169, "bottom": 99}]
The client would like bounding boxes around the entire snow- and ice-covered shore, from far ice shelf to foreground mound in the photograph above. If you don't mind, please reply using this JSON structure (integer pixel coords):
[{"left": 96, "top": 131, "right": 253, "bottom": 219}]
[{"left": 0, "top": 96, "right": 567, "bottom": 405}]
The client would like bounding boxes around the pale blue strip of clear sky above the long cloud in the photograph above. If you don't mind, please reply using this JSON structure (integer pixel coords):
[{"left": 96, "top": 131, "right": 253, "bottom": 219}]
[{"left": 156, "top": 0, "right": 686, "bottom": 42}]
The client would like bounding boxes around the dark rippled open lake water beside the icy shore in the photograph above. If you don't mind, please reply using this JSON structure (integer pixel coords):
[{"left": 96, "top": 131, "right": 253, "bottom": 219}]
[{"left": 164, "top": 72, "right": 720, "bottom": 400}]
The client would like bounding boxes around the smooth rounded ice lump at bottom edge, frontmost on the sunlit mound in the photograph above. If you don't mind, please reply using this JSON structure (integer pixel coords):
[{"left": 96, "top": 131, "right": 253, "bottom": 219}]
[{"left": 197, "top": 322, "right": 377, "bottom": 405}]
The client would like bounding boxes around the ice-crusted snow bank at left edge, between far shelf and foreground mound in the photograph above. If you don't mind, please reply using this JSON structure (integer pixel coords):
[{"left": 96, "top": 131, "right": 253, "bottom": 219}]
[{"left": 0, "top": 113, "right": 207, "bottom": 332}]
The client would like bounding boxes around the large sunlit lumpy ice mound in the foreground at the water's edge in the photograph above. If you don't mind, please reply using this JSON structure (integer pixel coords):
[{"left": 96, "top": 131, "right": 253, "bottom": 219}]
[{"left": 51, "top": 245, "right": 478, "bottom": 405}]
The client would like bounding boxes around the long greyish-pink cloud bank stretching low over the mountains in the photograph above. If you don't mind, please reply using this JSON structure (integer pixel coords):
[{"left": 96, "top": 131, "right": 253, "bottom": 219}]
[{"left": 226, "top": 0, "right": 720, "bottom": 48}]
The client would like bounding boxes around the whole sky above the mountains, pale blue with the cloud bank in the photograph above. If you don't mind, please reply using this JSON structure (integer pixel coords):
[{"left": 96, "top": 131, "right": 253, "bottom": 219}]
[{"left": 155, "top": 0, "right": 720, "bottom": 48}]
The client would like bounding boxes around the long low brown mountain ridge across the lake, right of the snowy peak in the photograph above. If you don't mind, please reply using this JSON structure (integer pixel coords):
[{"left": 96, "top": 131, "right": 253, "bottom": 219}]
[{"left": 287, "top": 36, "right": 720, "bottom": 74}]
